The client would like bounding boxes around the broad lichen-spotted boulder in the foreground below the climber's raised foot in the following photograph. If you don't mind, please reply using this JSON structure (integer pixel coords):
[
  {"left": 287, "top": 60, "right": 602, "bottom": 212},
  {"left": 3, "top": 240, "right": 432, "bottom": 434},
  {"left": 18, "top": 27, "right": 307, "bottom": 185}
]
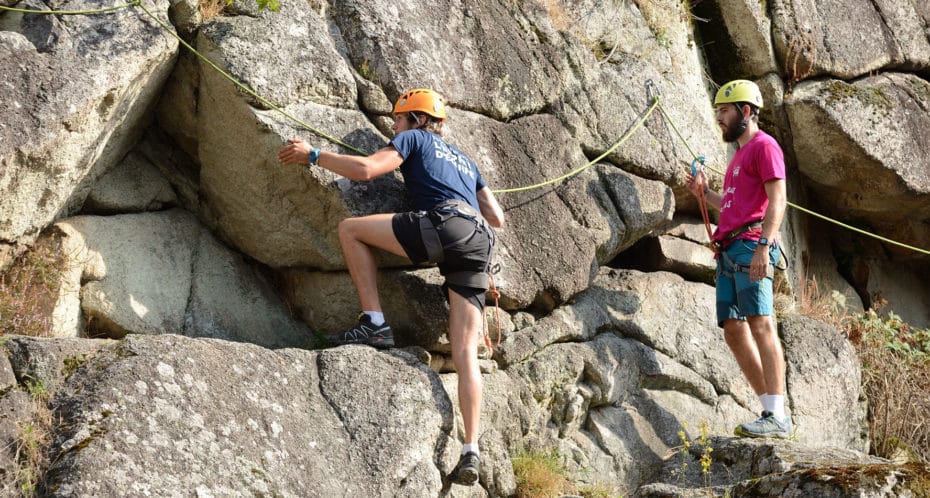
[{"left": 6, "top": 335, "right": 455, "bottom": 496}]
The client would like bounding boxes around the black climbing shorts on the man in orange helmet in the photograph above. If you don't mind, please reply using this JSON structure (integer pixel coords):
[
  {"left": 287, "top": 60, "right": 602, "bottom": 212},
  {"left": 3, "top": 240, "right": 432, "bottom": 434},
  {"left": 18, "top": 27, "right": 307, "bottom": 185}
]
[{"left": 391, "top": 208, "right": 491, "bottom": 310}]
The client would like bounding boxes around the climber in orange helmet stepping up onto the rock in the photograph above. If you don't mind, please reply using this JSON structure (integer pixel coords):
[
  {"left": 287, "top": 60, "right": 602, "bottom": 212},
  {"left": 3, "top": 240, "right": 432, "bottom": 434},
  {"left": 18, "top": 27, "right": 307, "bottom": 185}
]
[{"left": 278, "top": 89, "right": 504, "bottom": 485}]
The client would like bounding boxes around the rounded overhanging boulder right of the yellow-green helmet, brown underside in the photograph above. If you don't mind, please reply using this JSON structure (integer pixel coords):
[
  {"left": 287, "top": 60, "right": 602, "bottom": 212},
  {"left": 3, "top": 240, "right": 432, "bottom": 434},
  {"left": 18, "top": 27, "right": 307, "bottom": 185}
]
[{"left": 785, "top": 73, "right": 930, "bottom": 225}]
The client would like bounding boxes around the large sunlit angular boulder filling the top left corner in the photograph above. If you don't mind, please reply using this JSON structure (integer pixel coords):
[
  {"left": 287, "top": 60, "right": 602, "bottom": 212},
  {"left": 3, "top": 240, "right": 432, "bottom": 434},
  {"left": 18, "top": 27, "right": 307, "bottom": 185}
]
[{"left": 0, "top": 0, "right": 177, "bottom": 256}]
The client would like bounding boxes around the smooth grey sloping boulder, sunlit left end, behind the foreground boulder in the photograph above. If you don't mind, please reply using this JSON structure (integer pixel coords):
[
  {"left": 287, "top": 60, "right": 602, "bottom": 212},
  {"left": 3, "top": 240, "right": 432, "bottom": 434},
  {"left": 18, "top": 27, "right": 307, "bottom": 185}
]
[{"left": 56, "top": 209, "right": 313, "bottom": 348}]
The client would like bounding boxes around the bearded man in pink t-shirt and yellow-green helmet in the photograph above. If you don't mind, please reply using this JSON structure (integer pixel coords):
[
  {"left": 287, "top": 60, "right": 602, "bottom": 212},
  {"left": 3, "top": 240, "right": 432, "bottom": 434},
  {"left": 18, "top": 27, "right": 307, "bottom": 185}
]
[{"left": 688, "top": 80, "right": 793, "bottom": 438}]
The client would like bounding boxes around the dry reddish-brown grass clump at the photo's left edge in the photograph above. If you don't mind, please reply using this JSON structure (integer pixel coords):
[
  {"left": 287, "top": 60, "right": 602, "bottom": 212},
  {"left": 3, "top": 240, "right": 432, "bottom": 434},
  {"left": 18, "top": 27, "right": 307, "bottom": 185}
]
[{"left": 0, "top": 236, "right": 67, "bottom": 337}]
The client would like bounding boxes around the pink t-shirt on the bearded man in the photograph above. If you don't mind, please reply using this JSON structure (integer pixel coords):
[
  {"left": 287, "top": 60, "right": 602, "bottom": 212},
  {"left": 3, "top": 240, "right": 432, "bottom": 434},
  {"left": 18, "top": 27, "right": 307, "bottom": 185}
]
[{"left": 714, "top": 130, "right": 785, "bottom": 240}]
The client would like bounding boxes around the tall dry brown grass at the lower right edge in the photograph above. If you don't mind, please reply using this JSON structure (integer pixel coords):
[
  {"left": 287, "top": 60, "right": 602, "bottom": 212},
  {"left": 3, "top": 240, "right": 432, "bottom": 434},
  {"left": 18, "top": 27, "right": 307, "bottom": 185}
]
[{"left": 846, "top": 303, "right": 930, "bottom": 464}]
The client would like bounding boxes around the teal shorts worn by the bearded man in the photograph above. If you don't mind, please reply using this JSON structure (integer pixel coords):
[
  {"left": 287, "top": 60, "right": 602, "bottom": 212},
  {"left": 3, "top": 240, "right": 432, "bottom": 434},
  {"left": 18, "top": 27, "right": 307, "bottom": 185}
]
[{"left": 717, "top": 239, "right": 781, "bottom": 327}]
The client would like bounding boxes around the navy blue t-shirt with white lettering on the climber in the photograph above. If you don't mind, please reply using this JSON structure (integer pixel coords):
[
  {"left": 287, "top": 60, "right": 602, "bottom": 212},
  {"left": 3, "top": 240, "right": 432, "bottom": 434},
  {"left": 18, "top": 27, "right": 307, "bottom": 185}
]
[{"left": 388, "top": 130, "right": 485, "bottom": 211}]
